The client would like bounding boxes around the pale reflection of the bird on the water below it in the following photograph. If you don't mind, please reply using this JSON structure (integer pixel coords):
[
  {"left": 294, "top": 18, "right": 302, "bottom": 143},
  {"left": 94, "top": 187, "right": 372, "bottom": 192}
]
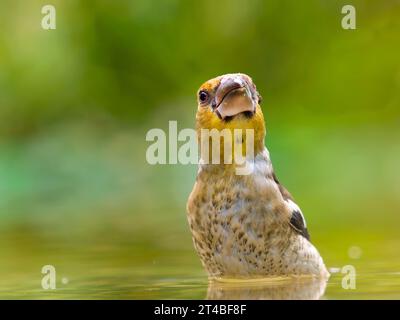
[{"left": 207, "top": 278, "right": 327, "bottom": 300}]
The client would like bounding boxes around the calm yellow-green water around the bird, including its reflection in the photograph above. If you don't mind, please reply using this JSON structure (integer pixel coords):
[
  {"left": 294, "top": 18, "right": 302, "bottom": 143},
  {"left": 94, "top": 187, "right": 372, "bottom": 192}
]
[{"left": 0, "top": 220, "right": 400, "bottom": 299}]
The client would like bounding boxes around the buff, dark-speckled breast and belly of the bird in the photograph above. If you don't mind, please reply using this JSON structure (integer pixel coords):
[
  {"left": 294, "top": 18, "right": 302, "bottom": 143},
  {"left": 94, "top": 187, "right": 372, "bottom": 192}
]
[{"left": 188, "top": 155, "right": 325, "bottom": 277}]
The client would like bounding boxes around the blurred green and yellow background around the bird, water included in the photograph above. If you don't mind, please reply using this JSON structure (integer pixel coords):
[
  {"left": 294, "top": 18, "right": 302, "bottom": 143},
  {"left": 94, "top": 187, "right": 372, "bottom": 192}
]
[{"left": 0, "top": 0, "right": 400, "bottom": 298}]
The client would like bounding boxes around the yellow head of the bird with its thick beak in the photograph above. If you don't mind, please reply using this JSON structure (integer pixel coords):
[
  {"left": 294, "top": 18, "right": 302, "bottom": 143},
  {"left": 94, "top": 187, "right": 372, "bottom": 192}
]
[{"left": 196, "top": 73, "right": 266, "bottom": 159}]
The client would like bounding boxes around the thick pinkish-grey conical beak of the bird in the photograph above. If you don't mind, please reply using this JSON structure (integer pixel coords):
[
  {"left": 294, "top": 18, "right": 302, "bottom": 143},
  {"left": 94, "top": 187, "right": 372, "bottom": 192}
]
[{"left": 212, "top": 74, "right": 257, "bottom": 119}]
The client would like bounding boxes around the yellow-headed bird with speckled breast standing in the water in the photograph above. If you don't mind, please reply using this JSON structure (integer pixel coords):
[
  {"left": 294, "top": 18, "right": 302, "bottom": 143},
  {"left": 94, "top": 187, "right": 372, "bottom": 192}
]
[{"left": 186, "top": 73, "right": 329, "bottom": 279}]
